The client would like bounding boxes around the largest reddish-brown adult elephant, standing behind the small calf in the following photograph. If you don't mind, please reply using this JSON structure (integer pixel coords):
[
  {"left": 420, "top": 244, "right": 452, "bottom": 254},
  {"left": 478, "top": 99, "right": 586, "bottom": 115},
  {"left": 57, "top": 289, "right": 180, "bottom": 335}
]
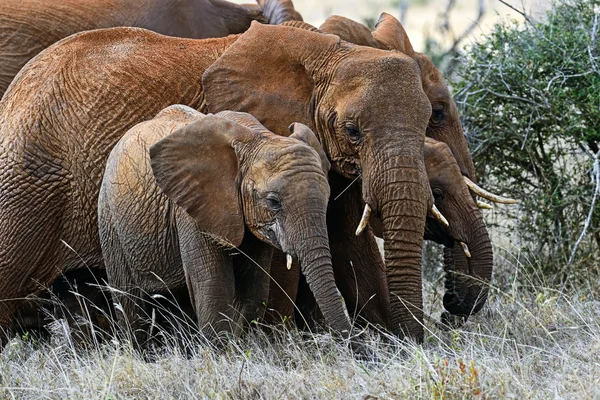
[{"left": 0, "top": 22, "right": 433, "bottom": 340}]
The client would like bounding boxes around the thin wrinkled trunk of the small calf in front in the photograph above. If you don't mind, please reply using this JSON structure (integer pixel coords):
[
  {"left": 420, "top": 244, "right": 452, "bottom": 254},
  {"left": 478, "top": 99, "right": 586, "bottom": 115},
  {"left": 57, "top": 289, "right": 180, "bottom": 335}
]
[{"left": 297, "top": 230, "right": 351, "bottom": 337}]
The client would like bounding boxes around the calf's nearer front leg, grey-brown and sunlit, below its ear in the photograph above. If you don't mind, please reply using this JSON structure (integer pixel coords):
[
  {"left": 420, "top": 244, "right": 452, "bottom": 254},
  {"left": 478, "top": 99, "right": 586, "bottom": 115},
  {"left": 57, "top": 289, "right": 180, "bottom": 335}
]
[{"left": 177, "top": 210, "right": 237, "bottom": 339}]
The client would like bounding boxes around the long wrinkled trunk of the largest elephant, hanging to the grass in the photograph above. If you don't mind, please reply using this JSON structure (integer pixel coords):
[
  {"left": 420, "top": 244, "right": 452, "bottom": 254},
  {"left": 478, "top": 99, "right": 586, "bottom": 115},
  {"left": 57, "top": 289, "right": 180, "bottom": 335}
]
[{"left": 363, "top": 149, "right": 430, "bottom": 341}]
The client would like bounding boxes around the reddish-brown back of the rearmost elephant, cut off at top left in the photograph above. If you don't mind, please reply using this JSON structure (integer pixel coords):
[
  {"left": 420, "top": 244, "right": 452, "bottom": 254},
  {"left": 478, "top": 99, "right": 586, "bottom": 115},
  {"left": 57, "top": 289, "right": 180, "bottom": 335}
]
[{"left": 0, "top": 0, "right": 302, "bottom": 98}]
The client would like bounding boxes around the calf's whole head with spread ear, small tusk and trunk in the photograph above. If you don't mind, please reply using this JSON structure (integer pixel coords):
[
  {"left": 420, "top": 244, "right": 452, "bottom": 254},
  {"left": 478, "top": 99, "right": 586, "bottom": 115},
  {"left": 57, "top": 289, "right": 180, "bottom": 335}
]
[{"left": 150, "top": 110, "right": 351, "bottom": 334}]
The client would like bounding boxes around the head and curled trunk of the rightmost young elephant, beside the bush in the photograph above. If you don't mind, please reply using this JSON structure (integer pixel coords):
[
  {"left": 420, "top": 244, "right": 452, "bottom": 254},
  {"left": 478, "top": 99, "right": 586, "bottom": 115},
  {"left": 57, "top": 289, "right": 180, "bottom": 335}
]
[{"left": 424, "top": 138, "right": 493, "bottom": 319}]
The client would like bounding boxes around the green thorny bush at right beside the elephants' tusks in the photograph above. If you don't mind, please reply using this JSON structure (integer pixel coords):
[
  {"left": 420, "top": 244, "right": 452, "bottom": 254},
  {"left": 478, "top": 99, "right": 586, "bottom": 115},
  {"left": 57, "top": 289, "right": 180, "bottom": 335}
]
[{"left": 455, "top": 0, "right": 600, "bottom": 283}]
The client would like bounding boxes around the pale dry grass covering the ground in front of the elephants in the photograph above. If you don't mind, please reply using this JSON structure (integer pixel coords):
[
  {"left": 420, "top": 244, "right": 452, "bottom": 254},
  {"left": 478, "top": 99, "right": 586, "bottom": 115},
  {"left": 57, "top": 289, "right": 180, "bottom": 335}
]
[{"left": 0, "top": 247, "right": 600, "bottom": 399}]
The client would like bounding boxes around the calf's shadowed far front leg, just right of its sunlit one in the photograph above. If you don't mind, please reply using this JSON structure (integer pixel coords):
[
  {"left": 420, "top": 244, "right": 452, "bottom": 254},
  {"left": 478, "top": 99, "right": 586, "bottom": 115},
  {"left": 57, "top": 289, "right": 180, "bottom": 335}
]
[{"left": 233, "top": 234, "right": 273, "bottom": 326}]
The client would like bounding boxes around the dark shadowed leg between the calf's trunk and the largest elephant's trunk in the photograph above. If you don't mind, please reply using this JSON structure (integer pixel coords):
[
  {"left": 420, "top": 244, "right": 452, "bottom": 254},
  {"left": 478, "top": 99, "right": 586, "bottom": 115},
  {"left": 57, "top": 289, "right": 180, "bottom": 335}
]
[{"left": 327, "top": 176, "right": 389, "bottom": 326}]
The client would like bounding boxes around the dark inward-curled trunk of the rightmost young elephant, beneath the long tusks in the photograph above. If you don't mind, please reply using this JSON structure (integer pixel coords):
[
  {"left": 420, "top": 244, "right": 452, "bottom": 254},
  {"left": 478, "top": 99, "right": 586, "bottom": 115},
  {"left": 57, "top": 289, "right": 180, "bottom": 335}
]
[{"left": 444, "top": 209, "right": 493, "bottom": 319}]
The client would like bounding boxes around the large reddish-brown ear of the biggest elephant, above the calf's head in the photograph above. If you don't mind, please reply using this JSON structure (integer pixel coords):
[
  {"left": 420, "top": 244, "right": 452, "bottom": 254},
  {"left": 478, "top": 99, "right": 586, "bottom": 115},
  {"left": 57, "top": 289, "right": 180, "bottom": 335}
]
[{"left": 202, "top": 23, "right": 340, "bottom": 136}]
